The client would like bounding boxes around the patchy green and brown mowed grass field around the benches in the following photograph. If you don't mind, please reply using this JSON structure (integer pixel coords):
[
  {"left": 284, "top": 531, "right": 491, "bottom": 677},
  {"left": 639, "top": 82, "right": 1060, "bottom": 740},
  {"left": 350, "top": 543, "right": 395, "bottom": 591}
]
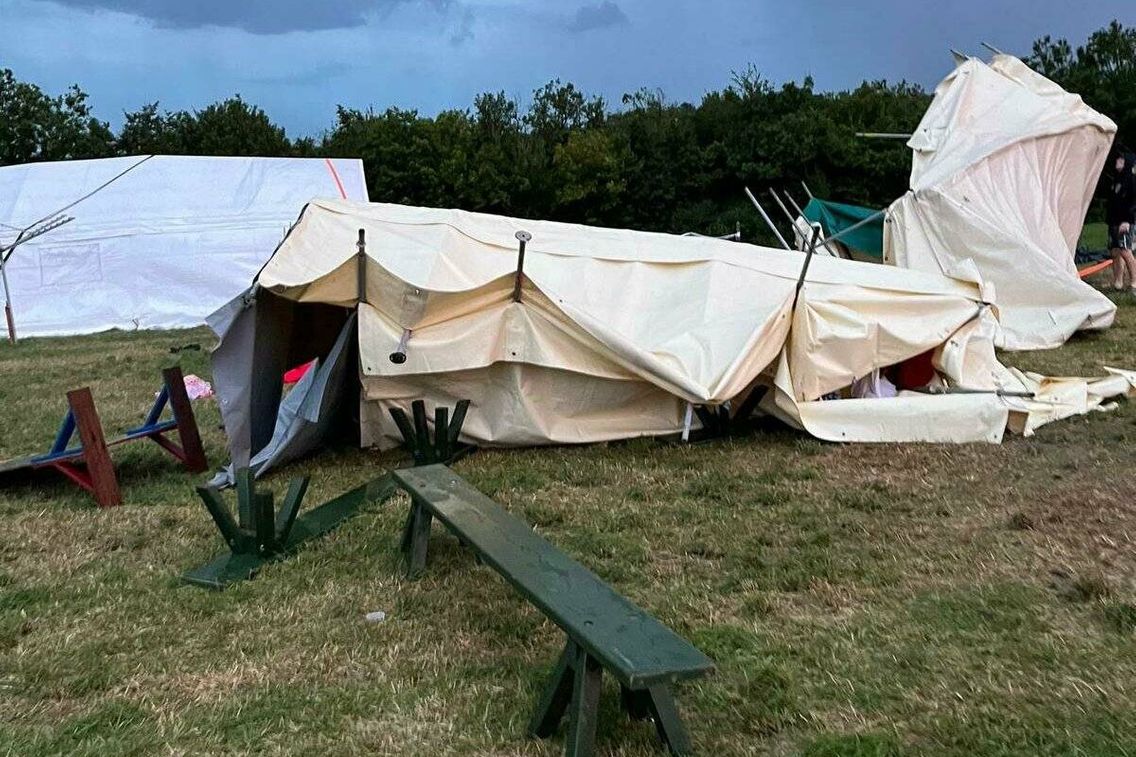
[{"left": 0, "top": 286, "right": 1136, "bottom": 756}]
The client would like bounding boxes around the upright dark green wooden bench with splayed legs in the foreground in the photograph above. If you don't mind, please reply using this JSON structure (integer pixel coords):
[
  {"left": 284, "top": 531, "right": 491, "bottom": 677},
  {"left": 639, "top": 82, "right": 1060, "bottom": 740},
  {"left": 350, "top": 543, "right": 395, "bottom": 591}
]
[{"left": 393, "top": 465, "right": 713, "bottom": 756}]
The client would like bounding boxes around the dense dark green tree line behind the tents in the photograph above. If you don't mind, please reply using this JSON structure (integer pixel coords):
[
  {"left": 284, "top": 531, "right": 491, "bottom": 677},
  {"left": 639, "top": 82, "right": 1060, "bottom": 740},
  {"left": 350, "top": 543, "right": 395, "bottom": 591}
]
[{"left": 0, "top": 22, "right": 1136, "bottom": 241}]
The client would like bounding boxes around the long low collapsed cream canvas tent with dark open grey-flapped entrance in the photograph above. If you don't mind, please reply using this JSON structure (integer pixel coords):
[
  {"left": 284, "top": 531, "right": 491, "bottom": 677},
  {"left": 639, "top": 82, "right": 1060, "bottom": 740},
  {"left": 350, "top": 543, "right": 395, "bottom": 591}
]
[{"left": 211, "top": 200, "right": 1136, "bottom": 467}]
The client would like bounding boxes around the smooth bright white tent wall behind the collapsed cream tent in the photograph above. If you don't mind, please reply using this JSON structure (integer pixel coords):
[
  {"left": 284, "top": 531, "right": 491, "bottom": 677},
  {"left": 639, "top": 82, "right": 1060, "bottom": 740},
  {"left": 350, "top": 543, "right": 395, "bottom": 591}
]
[{"left": 0, "top": 156, "right": 367, "bottom": 336}]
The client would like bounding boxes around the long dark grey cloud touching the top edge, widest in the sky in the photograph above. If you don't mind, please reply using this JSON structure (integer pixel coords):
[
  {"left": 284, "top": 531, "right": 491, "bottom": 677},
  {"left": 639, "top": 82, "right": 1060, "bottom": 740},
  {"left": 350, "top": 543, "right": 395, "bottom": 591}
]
[{"left": 40, "top": 0, "right": 453, "bottom": 34}]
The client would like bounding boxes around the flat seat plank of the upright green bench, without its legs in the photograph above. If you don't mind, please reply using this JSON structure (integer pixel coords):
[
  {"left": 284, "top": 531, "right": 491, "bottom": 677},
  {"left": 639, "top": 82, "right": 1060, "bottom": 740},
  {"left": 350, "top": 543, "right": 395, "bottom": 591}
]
[{"left": 394, "top": 465, "right": 713, "bottom": 690}]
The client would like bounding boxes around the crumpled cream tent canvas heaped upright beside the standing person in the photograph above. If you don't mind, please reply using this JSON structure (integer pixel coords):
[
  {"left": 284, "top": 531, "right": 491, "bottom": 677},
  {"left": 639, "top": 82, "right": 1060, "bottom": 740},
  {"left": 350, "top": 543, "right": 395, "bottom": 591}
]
[{"left": 884, "top": 55, "right": 1117, "bottom": 349}]
